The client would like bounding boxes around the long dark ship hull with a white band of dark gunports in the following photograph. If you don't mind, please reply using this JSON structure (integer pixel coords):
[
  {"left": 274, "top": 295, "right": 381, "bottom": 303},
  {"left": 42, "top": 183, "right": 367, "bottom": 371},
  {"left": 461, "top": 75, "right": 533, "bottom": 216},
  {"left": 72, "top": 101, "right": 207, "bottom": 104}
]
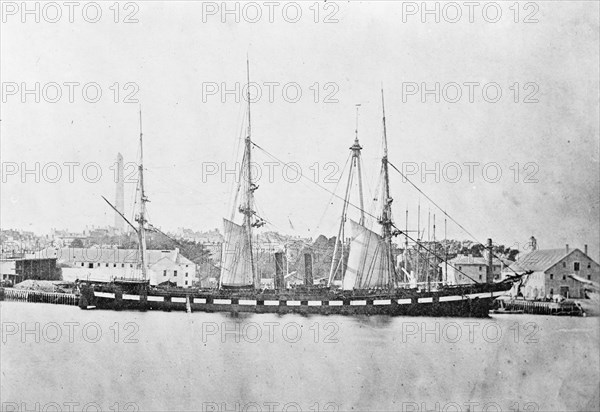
[{"left": 79, "top": 282, "right": 512, "bottom": 317}]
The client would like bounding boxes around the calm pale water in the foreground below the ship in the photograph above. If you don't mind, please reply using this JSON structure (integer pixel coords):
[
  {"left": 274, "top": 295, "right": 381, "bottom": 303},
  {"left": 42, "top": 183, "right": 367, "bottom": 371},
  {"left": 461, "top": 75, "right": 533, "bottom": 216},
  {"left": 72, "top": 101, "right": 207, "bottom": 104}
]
[{"left": 0, "top": 302, "right": 600, "bottom": 411}]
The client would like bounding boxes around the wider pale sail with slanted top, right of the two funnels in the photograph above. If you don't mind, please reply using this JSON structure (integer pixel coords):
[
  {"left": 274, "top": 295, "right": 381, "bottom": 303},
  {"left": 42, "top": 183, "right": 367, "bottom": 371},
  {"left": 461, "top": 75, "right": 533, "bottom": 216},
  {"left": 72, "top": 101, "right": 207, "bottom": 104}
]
[{"left": 342, "top": 219, "right": 390, "bottom": 290}]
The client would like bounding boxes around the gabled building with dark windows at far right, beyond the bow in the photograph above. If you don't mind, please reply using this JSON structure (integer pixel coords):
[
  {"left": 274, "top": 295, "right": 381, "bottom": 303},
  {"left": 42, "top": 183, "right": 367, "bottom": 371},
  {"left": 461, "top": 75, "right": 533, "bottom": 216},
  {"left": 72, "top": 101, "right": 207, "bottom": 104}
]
[{"left": 502, "top": 245, "right": 600, "bottom": 299}]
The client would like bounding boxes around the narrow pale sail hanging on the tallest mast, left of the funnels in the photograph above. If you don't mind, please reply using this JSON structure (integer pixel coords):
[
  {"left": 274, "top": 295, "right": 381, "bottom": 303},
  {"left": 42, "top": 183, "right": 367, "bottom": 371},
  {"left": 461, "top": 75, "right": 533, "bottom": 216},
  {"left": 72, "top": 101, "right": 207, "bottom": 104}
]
[{"left": 221, "top": 219, "right": 253, "bottom": 287}]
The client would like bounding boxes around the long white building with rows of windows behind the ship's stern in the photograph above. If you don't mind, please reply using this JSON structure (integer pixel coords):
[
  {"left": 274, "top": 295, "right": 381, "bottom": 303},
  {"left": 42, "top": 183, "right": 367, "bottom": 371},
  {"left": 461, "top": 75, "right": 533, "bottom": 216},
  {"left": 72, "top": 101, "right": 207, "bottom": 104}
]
[{"left": 41, "top": 247, "right": 198, "bottom": 288}]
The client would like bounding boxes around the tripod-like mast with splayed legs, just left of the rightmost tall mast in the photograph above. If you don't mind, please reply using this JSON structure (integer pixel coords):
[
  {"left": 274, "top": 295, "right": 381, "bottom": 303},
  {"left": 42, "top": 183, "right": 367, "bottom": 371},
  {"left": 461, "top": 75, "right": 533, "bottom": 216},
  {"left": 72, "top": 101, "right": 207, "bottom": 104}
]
[{"left": 327, "top": 104, "right": 365, "bottom": 286}]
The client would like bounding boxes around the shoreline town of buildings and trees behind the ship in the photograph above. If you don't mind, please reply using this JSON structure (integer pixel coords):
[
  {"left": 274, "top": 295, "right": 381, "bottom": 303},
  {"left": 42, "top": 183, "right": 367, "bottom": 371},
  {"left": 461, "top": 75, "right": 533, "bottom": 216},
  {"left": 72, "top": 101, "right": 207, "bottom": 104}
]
[{"left": 0, "top": 226, "right": 600, "bottom": 300}]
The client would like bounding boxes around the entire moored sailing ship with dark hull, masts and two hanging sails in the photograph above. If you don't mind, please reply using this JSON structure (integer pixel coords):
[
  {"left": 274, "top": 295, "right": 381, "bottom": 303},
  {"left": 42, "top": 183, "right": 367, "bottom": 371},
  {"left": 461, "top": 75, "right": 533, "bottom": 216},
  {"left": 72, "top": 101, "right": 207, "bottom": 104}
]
[{"left": 80, "top": 63, "right": 513, "bottom": 317}]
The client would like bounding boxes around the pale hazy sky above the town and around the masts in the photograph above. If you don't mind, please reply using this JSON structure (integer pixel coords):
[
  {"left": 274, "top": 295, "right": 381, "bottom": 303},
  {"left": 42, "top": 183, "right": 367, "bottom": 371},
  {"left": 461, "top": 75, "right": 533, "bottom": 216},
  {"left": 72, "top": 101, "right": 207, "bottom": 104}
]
[{"left": 0, "top": 1, "right": 600, "bottom": 260}]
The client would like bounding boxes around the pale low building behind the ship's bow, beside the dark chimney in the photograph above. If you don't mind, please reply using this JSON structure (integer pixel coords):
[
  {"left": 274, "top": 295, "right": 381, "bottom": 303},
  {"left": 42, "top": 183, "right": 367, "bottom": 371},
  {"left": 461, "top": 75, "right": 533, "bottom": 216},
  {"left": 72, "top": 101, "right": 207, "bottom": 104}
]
[{"left": 439, "top": 254, "right": 503, "bottom": 285}]
